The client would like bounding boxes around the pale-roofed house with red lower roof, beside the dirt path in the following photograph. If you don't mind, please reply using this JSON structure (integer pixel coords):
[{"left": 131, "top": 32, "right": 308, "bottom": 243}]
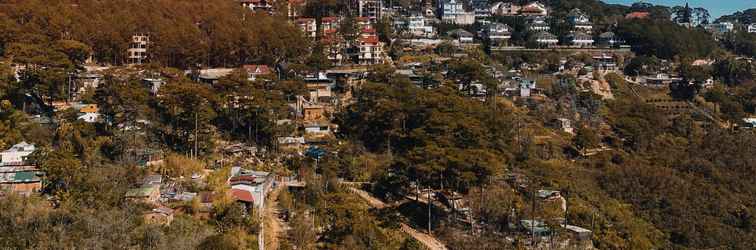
[{"left": 228, "top": 167, "right": 273, "bottom": 209}]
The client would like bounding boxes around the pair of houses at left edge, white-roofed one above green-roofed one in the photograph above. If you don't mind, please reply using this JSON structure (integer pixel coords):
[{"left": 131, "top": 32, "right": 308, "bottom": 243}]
[{"left": 0, "top": 142, "right": 44, "bottom": 197}]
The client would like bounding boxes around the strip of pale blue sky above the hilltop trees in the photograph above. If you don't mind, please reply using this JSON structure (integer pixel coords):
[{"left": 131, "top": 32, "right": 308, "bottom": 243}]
[{"left": 602, "top": 0, "right": 756, "bottom": 19}]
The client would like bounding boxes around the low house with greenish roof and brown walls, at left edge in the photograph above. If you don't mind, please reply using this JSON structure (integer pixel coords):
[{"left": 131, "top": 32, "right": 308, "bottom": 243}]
[{"left": 0, "top": 166, "right": 44, "bottom": 196}]
